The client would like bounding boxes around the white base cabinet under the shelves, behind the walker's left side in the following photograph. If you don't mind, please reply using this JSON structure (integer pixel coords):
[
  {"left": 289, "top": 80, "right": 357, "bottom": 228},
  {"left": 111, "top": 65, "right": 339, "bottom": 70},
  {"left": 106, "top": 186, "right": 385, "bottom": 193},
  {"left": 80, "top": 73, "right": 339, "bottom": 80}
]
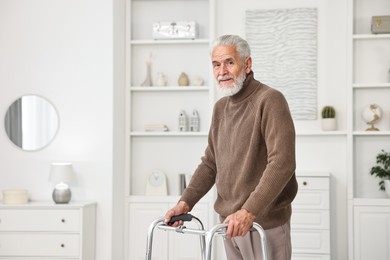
[{"left": 127, "top": 196, "right": 213, "bottom": 260}]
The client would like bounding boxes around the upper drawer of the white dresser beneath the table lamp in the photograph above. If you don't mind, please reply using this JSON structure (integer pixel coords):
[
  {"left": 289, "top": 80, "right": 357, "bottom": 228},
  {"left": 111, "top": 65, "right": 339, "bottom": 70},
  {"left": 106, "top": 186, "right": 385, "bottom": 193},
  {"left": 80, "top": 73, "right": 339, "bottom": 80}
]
[{"left": 0, "top": 209, "right": 80, "bottom": 231}]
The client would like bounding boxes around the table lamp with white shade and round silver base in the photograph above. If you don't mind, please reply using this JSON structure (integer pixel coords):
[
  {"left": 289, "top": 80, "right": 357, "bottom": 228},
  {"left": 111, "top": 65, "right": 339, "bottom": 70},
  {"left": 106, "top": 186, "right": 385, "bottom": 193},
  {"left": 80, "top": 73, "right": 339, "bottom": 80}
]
[{"left": 49, "top": 163, "right": 74, "bottom": 204}]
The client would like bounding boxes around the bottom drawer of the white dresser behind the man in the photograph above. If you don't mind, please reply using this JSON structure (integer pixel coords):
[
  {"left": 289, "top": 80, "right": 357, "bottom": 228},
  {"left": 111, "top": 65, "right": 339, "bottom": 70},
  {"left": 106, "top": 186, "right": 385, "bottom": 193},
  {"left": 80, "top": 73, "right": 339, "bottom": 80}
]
[{"left": 291, "top": 230, "right": 330, "bottom": 254}]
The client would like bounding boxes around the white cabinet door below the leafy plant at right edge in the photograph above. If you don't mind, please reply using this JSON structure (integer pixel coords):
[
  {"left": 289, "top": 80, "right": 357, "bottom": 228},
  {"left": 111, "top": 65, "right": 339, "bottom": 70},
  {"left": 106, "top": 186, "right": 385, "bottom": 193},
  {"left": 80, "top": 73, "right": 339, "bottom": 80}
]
[{"left": 353, "top": 202, "right": 390, "bottom": 260}]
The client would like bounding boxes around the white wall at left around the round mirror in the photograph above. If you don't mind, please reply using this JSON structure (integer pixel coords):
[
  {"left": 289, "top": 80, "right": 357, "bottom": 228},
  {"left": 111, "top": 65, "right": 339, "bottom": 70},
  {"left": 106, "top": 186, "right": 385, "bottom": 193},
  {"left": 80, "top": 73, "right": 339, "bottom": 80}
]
[{"left": 0, "top": 0, "right": 114, "bottom": 260}]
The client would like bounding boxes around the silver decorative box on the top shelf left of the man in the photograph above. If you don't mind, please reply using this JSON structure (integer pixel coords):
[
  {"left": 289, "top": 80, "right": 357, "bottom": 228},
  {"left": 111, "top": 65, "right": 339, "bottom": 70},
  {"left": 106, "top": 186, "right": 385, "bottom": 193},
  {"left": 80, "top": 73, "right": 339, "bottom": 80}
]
[{"left": 153, "top": 21, "right": 199, "bottom": 40}]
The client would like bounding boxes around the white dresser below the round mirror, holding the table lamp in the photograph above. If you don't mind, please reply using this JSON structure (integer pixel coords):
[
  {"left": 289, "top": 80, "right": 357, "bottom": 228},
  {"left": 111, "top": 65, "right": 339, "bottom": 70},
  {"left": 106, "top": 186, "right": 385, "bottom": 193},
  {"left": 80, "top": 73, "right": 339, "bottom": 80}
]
[{"left": 0, "top": 202, "right": 96, "bottom": 260}]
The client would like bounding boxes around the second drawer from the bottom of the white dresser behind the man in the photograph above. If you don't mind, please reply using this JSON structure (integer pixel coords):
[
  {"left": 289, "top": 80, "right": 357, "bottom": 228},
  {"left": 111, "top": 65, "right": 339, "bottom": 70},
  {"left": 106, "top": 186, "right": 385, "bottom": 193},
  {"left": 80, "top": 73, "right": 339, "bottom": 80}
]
[{"left": 291, "top": 209, "right": 330, "bottom": 230}]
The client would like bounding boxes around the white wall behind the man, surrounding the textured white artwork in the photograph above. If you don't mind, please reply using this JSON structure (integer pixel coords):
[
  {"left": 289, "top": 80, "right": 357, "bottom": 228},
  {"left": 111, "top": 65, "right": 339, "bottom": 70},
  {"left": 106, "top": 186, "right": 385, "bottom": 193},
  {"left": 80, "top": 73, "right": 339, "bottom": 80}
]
[{"left": 216, "top": 0, "right": 348, "bottom": 259}]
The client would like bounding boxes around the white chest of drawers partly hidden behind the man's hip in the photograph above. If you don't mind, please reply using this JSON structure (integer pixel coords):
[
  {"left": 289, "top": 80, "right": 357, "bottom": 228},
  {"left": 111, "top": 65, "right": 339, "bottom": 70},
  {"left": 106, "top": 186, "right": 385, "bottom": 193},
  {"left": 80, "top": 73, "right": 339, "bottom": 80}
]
[{"left": 291, "top": 173, "right": 330, "bottom": 260}]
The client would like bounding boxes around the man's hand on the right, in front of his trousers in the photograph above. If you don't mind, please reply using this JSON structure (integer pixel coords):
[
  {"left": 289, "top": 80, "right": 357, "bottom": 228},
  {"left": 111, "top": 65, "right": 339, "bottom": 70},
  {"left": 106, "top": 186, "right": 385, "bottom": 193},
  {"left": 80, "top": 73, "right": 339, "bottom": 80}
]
[{"left": 224, "top": 209, "right": 256, "bottom": 238}]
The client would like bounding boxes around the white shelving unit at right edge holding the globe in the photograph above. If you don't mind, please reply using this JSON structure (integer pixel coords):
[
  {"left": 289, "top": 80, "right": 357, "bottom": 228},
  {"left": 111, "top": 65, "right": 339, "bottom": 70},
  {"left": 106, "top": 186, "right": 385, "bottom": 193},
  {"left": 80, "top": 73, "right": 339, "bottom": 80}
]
[{"left": 347, "top": 0, "right": 390, "bottom": 260}]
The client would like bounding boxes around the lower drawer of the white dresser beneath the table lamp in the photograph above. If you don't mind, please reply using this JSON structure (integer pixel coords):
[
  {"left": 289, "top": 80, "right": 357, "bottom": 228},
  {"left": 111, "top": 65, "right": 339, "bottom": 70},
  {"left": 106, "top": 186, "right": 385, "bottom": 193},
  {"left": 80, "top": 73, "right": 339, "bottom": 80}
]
[{"left": 0, "top": 232, "right": 80, "bottom": 257}]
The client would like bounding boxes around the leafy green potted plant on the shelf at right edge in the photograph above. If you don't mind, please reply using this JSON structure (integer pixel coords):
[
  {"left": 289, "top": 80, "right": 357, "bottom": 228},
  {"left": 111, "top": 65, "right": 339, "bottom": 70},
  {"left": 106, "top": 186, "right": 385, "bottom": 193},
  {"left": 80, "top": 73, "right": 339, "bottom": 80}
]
[{"left": 370, "top": 150, "right": 390, "bottom": 197}]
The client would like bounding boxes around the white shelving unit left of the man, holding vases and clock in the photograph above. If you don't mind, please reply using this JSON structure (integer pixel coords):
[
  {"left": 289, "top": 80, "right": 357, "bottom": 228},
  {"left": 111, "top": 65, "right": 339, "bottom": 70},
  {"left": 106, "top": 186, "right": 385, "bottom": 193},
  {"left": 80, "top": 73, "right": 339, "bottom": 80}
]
[{"left": 125, "top": 0, "right": 215, "bottom": 259}]
